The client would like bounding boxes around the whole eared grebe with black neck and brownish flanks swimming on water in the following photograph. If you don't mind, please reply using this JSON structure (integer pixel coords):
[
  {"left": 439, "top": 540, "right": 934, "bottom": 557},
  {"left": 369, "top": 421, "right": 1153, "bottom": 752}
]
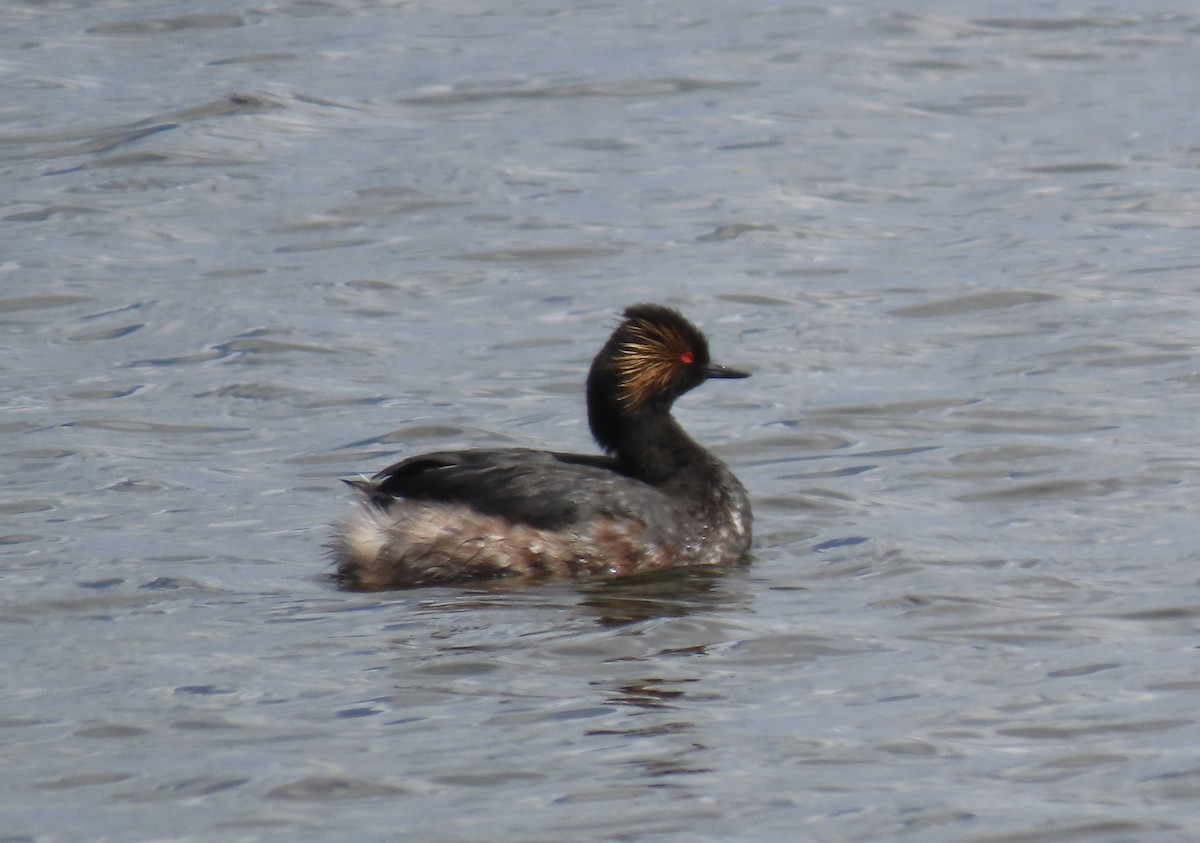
[{"left": 332, "top": 304, "right": 750, "bottom": 590}]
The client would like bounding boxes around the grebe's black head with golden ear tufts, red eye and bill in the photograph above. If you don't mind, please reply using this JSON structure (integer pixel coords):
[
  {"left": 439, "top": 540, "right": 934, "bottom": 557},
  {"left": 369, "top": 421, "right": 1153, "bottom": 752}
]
[{"left": 588, "top": 304, "right": 750, "bottom": 452}]
